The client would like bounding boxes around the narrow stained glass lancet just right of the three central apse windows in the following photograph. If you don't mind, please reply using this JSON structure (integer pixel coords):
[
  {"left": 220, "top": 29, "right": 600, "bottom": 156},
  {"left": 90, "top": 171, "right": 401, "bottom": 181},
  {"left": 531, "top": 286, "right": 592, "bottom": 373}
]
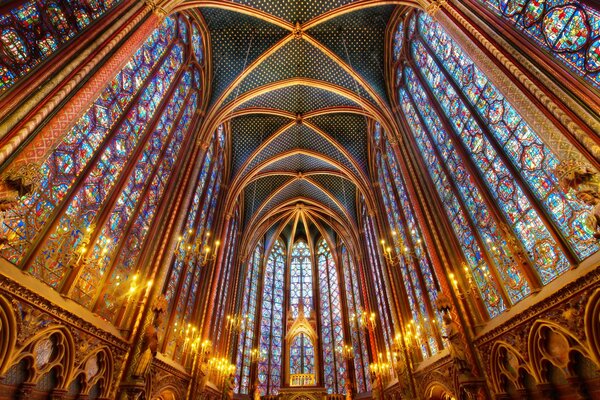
[{"left": 342, "top": 246, "right": 371, "bottom": 393}]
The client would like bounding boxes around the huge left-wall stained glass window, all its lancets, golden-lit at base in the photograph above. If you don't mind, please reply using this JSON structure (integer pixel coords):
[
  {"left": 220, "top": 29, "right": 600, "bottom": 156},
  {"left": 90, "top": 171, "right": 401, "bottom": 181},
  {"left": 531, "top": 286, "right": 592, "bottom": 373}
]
[{"left": 1, "top": 14, "right": 203, "bottom": 324}]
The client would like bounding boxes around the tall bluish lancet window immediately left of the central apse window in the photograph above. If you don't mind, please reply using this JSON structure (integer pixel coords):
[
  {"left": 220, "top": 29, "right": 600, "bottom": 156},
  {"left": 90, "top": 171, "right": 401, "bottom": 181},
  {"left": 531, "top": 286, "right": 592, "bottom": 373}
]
[{"left": 258, "top": 239, "right": 286, "bottom": 395}]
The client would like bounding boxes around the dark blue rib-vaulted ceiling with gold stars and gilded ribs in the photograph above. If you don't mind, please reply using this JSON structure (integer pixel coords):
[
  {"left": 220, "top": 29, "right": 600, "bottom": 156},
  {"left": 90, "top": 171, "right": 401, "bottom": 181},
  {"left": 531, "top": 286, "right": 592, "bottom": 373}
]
[{"left": 173, "top": 0, "right": 414, "bottom": 250}]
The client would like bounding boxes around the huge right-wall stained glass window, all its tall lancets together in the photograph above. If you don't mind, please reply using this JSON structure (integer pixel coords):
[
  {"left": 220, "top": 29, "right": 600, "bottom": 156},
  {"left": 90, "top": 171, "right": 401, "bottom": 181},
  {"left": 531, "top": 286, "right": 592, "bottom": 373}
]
[{"left": 394, "top": 13, "right": 598, "bottom": 317}]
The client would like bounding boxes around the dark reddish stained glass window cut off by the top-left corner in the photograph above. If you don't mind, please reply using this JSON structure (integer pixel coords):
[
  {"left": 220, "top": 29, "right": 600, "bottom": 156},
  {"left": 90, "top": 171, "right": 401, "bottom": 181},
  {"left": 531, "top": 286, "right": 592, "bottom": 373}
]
[{"left": 0, "top": 0, "right": 119, "bottom": 95}]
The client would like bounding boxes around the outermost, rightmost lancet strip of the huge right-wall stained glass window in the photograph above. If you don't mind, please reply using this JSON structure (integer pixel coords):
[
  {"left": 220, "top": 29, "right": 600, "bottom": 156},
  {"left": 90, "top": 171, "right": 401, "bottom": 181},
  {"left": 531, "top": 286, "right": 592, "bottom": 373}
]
[{"left": 419, "top": 14, "right": 598, "bottom": 264}]
